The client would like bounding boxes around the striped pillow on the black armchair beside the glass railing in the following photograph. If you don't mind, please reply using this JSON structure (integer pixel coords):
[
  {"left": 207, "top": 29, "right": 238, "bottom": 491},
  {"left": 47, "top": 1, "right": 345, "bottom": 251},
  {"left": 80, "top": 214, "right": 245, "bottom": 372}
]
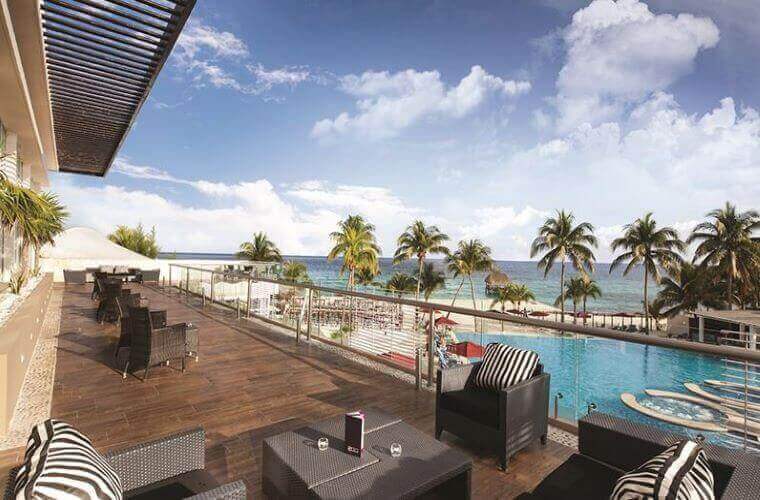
[{"left": 475, "top": 343, "right": 538, "bottom": 391}]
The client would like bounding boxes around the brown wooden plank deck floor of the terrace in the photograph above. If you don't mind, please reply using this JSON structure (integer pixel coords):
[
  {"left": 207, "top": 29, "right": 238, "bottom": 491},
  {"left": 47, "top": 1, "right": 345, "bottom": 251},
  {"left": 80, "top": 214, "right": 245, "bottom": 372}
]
[{"left": 0, "top": 285, "right": 572, "bottom": 498}]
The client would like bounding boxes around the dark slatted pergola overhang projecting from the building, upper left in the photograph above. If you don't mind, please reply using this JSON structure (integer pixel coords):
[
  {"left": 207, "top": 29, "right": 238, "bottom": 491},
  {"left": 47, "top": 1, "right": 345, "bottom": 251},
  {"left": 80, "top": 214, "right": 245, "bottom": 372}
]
[{"left": 42, "top": 0, "right": 195, "bottom": 176}]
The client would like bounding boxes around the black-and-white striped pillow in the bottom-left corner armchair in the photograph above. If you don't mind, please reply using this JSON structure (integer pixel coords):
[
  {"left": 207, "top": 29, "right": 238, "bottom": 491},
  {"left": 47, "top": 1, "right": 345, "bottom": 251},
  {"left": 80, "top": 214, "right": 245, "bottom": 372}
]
[{"left": 13, "top": 420, "right": 122, "bottom": 500}]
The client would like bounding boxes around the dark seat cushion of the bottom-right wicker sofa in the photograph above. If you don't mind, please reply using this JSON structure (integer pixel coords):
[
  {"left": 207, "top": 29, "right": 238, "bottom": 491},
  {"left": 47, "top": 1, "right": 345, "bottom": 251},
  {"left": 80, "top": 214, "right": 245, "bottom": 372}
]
[{"left": 531, "top": 454, "right": 623, "bottom": 500}]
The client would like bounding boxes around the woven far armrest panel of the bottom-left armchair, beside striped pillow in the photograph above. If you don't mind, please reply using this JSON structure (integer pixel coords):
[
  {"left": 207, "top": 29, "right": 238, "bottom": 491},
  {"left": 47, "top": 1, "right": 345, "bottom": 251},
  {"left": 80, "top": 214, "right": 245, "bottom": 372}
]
[{"left": 105, "top": 427, "right": 206, "bottom": 491}]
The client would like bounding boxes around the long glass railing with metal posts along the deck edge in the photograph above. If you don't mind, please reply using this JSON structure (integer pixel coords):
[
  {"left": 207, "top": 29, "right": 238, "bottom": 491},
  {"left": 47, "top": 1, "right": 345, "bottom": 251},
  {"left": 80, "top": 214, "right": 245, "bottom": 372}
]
[{"left": 163, "top": 265, "right": 760, "bottom": 452}]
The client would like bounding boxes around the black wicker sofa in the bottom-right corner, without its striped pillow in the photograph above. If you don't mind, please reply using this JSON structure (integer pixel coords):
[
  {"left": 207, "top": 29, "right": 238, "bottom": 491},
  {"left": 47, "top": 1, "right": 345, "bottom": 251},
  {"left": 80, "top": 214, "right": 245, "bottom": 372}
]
[{"left": 518, "top": 412, "right": 760, "bottom": 500}]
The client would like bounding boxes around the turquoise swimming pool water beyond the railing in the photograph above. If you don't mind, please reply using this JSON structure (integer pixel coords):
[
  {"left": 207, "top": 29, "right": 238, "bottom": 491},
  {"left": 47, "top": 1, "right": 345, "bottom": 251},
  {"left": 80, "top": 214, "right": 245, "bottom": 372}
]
[{"left": 456, "top": 333, "right": 744, "bottom": 444}]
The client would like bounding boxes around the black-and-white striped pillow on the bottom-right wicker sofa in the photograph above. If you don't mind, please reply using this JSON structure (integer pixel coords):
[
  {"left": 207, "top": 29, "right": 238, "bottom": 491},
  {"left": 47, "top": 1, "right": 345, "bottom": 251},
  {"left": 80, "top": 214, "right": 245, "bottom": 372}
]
[{"left": 610, "top": 440, "right": 715, "bottom": 500}]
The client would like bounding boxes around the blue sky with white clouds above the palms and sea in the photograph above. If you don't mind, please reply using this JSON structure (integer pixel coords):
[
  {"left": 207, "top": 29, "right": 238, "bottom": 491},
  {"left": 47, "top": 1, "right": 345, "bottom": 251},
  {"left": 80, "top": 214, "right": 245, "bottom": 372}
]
[{"left": 51, "top": 0, "right": 760, "bottom": 262}]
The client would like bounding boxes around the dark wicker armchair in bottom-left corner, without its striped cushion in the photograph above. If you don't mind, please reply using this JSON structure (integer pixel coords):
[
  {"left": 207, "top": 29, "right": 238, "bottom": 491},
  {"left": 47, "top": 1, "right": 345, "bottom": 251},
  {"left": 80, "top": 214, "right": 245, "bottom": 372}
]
[{"left": 4, "top": 428, "right": 246, "bottom": 500}]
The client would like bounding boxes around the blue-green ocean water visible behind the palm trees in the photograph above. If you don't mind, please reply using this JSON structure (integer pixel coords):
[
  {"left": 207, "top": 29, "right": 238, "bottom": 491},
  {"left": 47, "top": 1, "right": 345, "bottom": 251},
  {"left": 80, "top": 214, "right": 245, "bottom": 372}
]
[{"left": 159, "top": 252, "right": 657, "bottom": 312}]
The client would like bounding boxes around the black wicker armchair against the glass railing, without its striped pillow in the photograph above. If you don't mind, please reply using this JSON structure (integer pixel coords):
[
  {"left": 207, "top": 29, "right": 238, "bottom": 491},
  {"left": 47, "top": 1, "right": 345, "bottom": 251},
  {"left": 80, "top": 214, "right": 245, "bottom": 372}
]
[{"left": 435, "top": 361, "right": 549, "bottom": 470}]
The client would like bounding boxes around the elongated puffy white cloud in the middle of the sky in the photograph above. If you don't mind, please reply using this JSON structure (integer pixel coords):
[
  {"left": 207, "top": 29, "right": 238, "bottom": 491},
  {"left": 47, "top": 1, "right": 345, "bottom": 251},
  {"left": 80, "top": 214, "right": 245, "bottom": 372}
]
[{"left": 312, "top": 66, "right": 531, "bottom": 139}]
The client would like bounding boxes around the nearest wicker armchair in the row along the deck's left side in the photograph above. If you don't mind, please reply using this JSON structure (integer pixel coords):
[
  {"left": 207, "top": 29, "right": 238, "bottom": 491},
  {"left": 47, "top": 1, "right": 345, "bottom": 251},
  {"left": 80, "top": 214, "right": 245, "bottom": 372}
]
[{"left": 122, "top": 307, "right": 187, "bottom": 381}]
